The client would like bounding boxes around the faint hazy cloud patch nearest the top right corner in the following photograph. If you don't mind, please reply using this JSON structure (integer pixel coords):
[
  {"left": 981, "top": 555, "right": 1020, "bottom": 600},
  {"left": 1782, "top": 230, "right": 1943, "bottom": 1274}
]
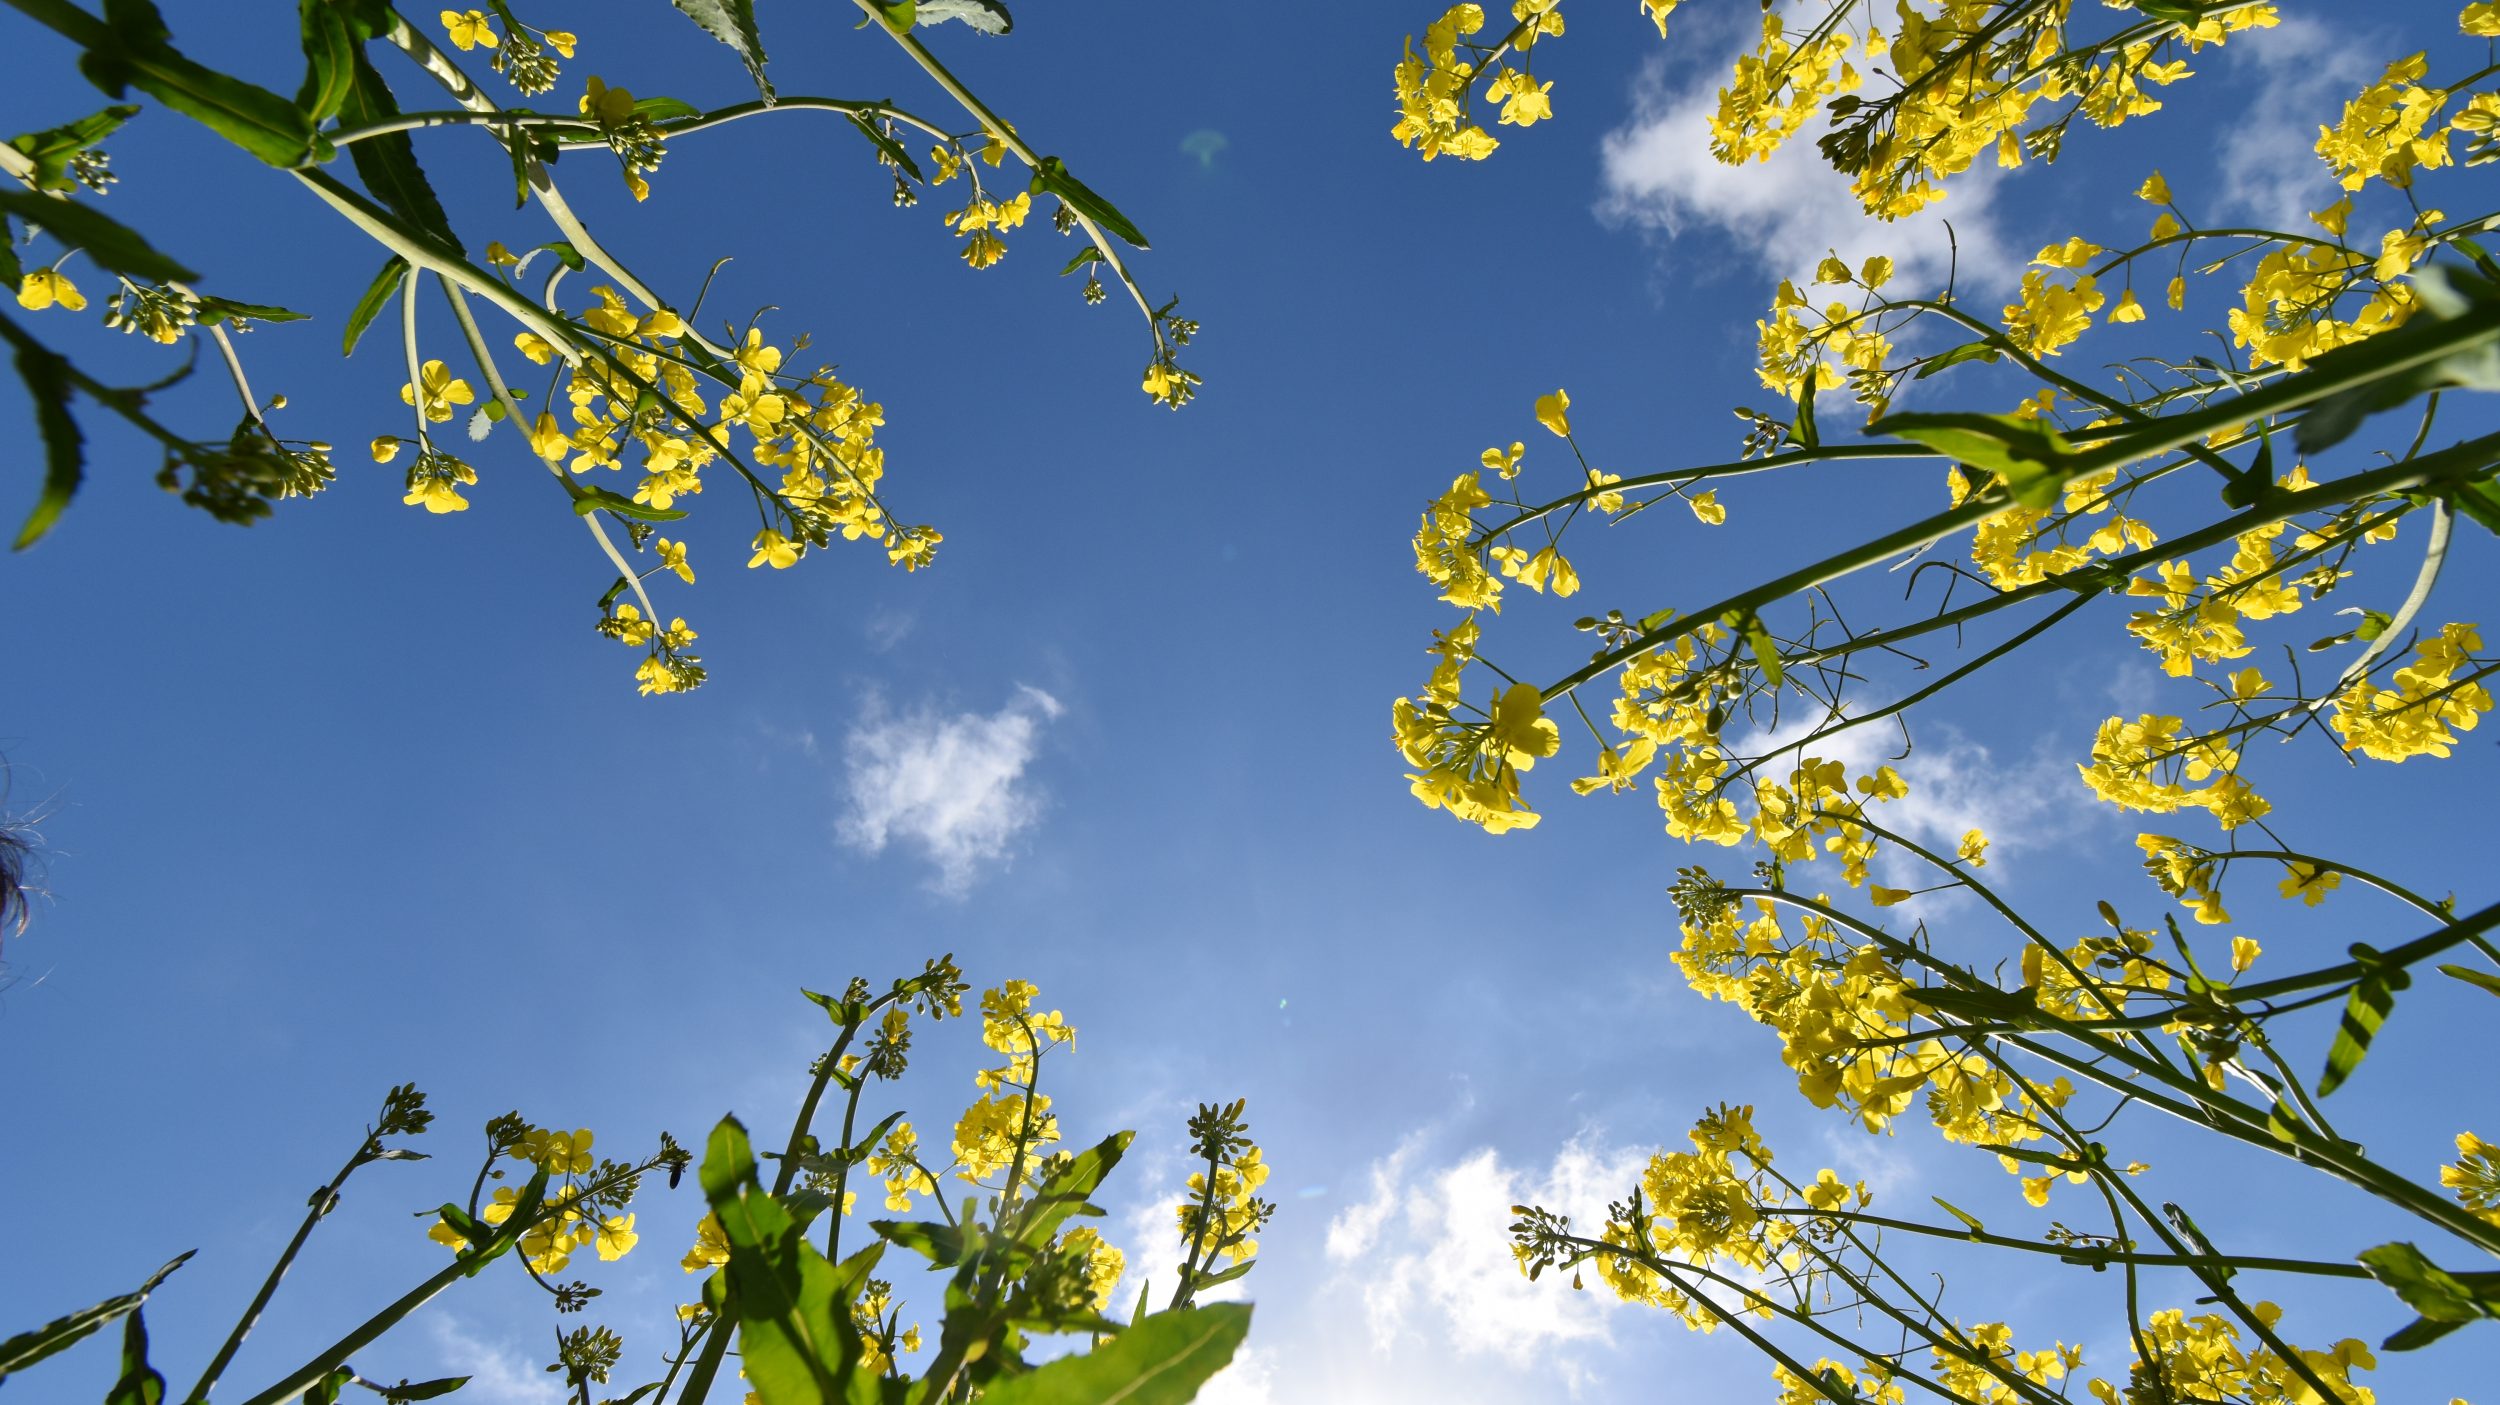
[{"left": 2220, "top": 15, "right": 2375, "bottom": 230}]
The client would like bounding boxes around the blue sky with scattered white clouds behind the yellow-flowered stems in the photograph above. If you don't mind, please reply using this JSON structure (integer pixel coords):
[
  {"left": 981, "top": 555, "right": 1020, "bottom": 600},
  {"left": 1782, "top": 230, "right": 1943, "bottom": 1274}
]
[{"left": 0, "top": 0, "right": 2500, "bottom": 1405}]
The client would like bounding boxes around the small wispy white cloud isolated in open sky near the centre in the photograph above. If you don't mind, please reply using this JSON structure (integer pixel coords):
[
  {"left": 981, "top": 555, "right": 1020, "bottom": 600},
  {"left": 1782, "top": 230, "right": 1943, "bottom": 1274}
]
[{"left": 840, "top": 685, "right": 1060, "bottom": 895}]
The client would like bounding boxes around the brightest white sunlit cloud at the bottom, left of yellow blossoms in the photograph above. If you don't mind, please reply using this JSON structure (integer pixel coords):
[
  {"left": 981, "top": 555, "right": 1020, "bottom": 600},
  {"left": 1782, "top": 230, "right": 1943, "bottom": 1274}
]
[{"left": 1328, "top": 1120, "right": 1645, "bottom": 1388}]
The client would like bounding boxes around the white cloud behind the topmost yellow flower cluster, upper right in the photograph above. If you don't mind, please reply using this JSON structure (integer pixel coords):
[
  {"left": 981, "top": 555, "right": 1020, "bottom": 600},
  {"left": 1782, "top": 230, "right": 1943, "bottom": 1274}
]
[{"left": 1598, "top": 53, "right": 2023, "bottom": 293}]
